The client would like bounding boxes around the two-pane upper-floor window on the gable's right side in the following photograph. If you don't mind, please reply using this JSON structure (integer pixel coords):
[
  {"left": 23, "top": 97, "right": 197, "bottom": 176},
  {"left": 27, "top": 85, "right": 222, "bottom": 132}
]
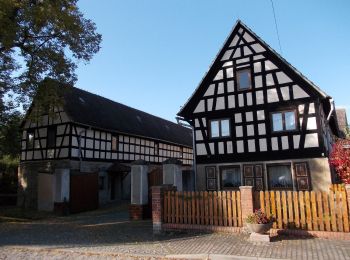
[{"left": 272, "top": 111, "right": 297, "bottom": 132}]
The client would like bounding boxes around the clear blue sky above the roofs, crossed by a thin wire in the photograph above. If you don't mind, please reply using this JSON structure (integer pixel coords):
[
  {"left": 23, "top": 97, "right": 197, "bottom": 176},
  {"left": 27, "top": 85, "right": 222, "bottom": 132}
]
[{"left": 76, "top": 0, "right": 350, "bottom": 121}]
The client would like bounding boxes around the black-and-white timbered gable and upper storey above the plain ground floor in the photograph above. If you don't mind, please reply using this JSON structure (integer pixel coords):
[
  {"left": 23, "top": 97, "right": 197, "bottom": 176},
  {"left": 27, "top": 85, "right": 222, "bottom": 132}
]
[{"left": 178, "top": 21, "right": 337, "bottom": 191}]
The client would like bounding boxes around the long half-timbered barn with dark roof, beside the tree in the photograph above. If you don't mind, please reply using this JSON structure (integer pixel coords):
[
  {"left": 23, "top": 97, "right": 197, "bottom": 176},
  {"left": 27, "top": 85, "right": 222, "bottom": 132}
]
[{"left": 18, "top": 84, "right": 193, "bottom": 211}]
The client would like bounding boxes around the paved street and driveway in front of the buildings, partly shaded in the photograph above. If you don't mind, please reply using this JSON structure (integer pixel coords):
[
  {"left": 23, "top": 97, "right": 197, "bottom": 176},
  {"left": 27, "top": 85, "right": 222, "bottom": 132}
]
[{"left": 0, "top": 206, "right": 350, "bottom": 260}]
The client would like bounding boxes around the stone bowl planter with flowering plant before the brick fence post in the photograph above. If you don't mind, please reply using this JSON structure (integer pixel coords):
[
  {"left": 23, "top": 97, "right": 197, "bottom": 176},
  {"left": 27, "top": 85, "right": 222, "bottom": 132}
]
[{"left": 246, "top": 209, "right": 273, "bottom": 234}]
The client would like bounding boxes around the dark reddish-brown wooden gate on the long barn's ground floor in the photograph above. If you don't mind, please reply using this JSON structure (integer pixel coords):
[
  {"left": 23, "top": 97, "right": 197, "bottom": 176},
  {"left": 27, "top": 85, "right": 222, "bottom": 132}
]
[{"left": 70, "top": 173, "right": 98, "bottom": 213}]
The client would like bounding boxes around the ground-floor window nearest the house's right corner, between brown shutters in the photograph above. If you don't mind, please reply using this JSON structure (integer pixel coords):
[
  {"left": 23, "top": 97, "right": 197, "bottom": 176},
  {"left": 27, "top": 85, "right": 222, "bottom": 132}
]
[{"left": 267, "top": 164, "right": 293, "bottom": 190}]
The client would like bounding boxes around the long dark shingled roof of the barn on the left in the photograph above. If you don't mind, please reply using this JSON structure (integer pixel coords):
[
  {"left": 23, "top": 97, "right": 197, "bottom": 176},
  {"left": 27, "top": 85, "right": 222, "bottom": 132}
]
[{"left": 63, "top": 87, "right": 192, "bottom": 147}]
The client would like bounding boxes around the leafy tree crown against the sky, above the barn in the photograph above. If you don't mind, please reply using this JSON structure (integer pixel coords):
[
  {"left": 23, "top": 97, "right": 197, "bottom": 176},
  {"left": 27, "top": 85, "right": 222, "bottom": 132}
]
[{"left": 0, "top": 0, "right": 102, "bottom": 112}]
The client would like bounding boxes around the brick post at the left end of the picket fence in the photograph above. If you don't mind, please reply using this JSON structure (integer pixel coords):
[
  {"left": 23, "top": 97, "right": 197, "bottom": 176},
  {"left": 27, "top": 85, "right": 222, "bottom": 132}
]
[{"left": 152, "top": 185, "right": 176, "bottom": 234}]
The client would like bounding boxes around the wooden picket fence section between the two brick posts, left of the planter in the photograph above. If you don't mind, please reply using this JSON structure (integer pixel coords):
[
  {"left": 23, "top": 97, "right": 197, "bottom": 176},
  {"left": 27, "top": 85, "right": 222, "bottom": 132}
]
[{"left": 163, "top": 191, "right": 242, "bottom": 227}]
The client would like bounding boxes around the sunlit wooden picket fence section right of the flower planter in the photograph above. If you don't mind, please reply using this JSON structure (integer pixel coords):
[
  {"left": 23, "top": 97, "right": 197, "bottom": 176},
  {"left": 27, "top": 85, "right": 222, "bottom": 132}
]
[{"left": 255, "top": 190, "right": 349, "bottom": 232}]
